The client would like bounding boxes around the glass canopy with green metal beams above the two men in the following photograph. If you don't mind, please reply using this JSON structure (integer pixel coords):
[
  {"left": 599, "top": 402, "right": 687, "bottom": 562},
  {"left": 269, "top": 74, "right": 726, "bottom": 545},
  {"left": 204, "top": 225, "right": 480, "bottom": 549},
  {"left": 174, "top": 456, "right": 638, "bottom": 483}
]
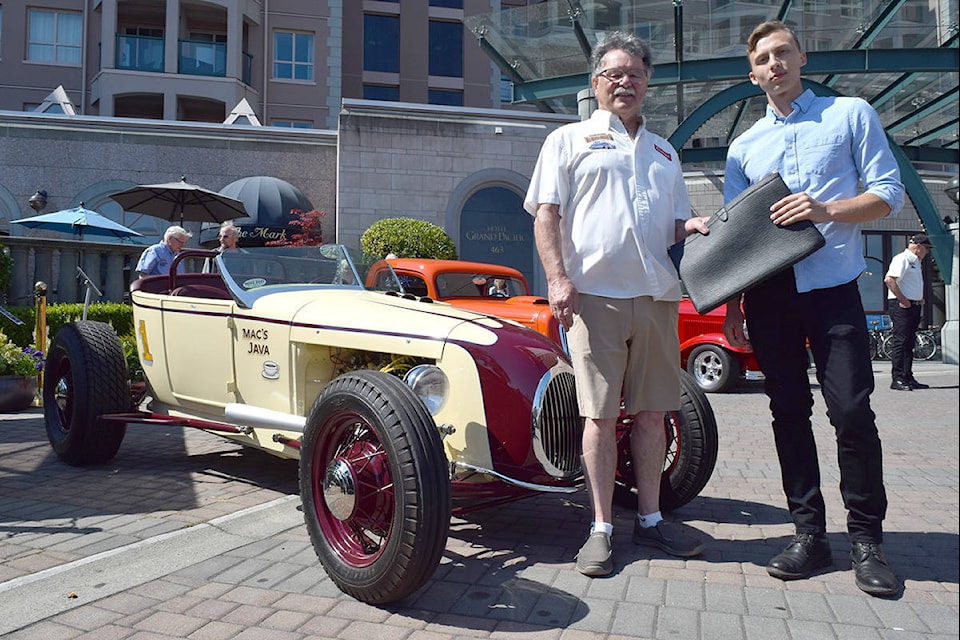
[{"left": 465, "top": 0, "right": 960, "bottom": 166}]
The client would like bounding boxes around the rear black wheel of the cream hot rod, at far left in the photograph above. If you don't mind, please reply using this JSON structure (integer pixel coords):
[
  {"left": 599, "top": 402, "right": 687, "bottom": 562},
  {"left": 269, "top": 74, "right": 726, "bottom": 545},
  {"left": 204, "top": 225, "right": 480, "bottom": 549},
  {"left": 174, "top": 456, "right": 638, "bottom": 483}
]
[{"left": 43, "top": 321, "right": 132, "bottom": 467}]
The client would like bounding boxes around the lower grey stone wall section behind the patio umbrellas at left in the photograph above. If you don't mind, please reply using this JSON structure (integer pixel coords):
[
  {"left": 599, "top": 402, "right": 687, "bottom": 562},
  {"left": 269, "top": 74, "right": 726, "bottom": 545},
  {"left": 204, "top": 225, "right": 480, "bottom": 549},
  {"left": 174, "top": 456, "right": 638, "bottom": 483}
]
[{"left": 0, "top": 112, "right": 337, "bottom": 246}]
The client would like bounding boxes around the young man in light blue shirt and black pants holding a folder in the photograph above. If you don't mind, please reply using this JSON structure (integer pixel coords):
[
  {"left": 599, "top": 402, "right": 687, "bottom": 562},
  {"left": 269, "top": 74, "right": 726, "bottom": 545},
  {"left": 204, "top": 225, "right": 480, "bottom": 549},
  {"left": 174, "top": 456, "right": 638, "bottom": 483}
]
[{"left": 724, "top": 21, "right": 904, "bottom": 596}]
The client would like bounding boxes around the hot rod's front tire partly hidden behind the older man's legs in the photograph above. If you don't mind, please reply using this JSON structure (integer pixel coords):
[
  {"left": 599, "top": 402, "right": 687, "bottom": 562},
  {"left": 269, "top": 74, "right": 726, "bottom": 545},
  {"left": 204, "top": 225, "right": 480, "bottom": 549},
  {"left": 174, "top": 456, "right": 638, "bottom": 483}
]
[{"left": 613, "top": 371, "right": 720, "bottom": 511}]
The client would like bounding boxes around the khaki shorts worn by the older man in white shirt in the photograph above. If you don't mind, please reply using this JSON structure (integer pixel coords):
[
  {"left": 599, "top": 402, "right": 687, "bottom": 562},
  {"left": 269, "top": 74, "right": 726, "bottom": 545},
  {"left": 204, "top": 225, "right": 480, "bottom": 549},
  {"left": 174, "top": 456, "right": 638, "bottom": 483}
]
[{"left": 567, "top": 294, "right": 680, "bottom": 419}]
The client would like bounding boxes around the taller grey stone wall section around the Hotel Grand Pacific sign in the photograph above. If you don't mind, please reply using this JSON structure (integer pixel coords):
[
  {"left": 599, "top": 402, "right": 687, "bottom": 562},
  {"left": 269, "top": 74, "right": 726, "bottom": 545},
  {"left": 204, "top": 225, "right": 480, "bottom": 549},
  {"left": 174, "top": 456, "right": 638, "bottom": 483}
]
[{"left": 337, "top": 100, "right": 571, "bottom": 246}]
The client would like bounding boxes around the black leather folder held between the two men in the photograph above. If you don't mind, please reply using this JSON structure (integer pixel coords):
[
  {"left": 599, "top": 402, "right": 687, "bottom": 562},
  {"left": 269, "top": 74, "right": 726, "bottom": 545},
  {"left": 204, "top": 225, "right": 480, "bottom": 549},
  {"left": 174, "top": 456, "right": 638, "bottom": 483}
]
[{"left": 670, "top": 172, "right": 824, "bottom": 313}]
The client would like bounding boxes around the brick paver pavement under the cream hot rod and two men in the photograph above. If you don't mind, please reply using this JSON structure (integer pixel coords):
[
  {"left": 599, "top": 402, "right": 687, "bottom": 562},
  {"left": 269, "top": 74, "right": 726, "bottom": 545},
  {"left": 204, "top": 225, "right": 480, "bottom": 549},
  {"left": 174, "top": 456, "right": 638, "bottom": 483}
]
[{"left": 0, "top": 362, "right": 960, "bottom": 640}]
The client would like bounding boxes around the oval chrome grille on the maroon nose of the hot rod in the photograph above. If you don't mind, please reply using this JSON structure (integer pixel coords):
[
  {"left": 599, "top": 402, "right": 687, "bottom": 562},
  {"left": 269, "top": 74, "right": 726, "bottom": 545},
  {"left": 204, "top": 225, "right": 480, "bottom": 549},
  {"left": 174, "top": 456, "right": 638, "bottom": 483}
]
[{"left": 532, "top": 363, "right": 583, "bottom": 478}]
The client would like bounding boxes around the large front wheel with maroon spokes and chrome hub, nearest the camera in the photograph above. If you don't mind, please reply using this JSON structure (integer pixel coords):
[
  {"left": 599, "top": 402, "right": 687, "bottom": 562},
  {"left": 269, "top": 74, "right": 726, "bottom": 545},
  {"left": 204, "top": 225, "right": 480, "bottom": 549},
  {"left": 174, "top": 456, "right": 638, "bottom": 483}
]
[{"left": 300, "top": 371, "right": 451, "bottom": 604}]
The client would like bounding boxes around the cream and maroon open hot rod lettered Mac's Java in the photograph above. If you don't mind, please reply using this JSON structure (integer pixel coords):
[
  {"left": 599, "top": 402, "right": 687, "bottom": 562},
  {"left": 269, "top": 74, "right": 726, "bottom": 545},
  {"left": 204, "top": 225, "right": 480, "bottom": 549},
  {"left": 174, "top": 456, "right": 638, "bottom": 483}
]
[{"left": 43, "top": 245, "right": 716, "bottom": 603}]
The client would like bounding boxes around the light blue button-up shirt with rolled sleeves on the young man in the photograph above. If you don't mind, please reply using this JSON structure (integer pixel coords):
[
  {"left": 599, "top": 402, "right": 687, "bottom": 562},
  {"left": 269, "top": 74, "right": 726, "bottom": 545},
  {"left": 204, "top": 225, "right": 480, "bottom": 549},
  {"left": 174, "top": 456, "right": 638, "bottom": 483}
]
[{"left": 723, "top": 89, "right": 904, "bottom": 293}]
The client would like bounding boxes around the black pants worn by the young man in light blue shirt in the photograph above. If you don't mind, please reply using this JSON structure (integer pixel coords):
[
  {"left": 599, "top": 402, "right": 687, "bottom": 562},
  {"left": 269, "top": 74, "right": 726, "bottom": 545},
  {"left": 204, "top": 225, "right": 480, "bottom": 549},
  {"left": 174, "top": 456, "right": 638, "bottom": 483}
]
[{"left": 744, "top": 269, "right": 887, "bottom": 543}]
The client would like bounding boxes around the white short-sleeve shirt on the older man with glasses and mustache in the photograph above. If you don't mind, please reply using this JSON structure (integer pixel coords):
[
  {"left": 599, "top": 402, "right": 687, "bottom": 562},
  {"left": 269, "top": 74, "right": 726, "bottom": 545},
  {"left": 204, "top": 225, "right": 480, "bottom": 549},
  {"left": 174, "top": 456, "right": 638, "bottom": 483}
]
[{"left": 524, "top": 110, "right": 690, "bottom": 301}]
